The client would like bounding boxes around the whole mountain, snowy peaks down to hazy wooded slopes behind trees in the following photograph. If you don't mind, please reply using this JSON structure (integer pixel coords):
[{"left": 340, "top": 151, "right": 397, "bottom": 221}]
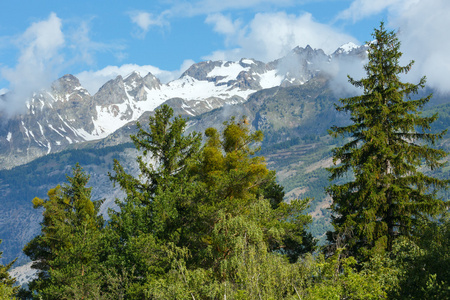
[{"left": 0, "top": 45, "right": 376, "bottom": 262}]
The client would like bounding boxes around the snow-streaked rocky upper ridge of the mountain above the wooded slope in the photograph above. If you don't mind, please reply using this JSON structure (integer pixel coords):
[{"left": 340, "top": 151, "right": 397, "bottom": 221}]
[{"left": 0, "top": 44, "right": 365, "bottom": 168}]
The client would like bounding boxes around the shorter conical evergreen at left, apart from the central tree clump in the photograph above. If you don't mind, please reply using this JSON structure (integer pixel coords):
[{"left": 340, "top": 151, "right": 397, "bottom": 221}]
[{"left": 24, "top": 164, "right": 103, "bottom": 299}]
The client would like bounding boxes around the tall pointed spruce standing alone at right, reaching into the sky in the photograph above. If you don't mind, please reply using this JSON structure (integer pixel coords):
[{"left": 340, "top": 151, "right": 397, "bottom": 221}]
[{"left": 327, "top": 23, "right": 449, "bottom": 256}]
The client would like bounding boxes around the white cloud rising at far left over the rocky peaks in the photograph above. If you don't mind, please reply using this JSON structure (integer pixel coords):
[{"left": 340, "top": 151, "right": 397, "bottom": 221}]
[{"left": 0, "top": 13, "right": 130, "bottom": 116}]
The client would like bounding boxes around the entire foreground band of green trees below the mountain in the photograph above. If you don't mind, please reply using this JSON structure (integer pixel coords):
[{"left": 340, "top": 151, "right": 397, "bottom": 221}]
[{"left": 0, "top": 23, "right": 450, "bottom": 300}]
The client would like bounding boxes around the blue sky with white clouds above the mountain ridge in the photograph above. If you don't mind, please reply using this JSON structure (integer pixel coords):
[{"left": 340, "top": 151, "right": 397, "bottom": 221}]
[{"left": 0, "top": 0, "right": 450, "bottom": 110}]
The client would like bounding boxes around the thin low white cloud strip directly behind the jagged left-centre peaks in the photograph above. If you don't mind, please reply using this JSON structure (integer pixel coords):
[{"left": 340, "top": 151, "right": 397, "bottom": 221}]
[{"left": 75, "top": 59, "right": 194, "bottom": 95}]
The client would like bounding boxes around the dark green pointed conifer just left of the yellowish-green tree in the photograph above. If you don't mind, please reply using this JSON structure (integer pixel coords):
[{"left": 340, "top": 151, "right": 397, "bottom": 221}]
[{"left": 104, "top": 105, "right": 201, "bottom": 298}]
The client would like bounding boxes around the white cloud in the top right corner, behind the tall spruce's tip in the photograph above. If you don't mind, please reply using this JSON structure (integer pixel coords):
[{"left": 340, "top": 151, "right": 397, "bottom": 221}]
[{"left": 337, "top": 0, "right": 450, "bottom": 93}]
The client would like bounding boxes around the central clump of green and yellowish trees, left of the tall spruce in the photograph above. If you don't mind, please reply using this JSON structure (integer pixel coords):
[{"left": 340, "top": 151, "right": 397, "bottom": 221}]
[{"left": 104, "top": 106, "right": 315, "bottom": 299}]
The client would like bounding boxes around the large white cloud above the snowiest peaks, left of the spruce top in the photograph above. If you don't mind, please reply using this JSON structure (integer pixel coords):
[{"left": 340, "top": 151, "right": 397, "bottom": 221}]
[{"left": 205, "top": 12, "right": 357, "bottom": 62}]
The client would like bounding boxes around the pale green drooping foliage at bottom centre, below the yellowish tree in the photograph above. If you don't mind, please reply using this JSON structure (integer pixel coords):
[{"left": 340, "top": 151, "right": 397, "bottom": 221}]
[{"left": 148, "top": 200, "right": 312, "bottom": 299}]
